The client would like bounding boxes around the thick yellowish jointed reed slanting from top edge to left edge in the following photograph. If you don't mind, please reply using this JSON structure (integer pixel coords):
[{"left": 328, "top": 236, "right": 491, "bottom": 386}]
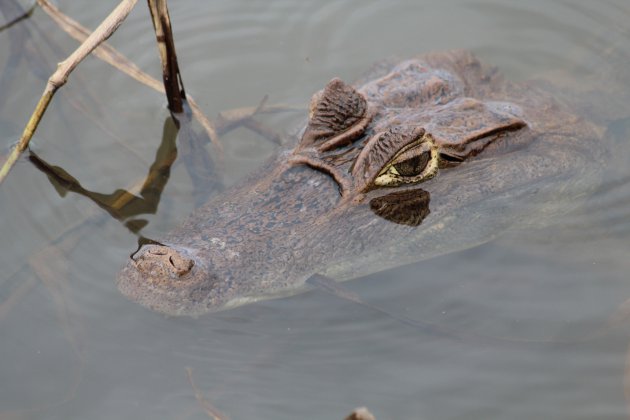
[{"left": 0, "top": 0, "right": 138, "bottom": 183}]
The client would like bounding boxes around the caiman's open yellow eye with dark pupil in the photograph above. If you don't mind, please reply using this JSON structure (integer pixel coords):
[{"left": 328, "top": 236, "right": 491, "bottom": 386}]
[{"left": 374, "top": 134, "right": 438, "bottom": 187}]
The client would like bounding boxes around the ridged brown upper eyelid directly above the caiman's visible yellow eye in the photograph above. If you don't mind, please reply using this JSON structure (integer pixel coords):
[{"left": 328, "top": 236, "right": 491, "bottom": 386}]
[{"left": 352, "top": 127, "right": 425, "bottom": 191}]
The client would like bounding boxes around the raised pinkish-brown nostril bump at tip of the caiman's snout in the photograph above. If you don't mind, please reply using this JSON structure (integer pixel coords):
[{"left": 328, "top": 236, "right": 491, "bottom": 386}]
[{"left": 134, "top": 245, "right": 195, "bottom": 279}]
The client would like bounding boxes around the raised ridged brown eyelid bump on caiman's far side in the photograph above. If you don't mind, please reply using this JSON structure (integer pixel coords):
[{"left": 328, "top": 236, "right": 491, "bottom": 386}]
[{"left": 300, "top": 79, "right": 372, "bottom": 152}]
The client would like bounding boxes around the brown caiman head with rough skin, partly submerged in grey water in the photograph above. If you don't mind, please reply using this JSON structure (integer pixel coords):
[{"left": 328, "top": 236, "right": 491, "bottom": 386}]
[{"left": 117, "top": 51, "right": 606, "bottom": 316}]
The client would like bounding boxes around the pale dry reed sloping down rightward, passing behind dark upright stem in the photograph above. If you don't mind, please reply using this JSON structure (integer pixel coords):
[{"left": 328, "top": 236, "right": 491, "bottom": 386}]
[{"left": 37, "top": 0, "right": 223, "bottom": 155}]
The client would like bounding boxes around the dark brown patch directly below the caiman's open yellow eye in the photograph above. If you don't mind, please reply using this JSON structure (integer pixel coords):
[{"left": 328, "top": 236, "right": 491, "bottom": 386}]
[{"left": 370, "top": 188, "right": 431, "bottom": 226}]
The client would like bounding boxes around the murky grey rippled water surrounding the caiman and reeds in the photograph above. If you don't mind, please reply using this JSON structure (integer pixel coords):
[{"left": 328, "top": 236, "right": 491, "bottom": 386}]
[{"left": 0, "top": 0, "right": 630, "bottom": 419}]
